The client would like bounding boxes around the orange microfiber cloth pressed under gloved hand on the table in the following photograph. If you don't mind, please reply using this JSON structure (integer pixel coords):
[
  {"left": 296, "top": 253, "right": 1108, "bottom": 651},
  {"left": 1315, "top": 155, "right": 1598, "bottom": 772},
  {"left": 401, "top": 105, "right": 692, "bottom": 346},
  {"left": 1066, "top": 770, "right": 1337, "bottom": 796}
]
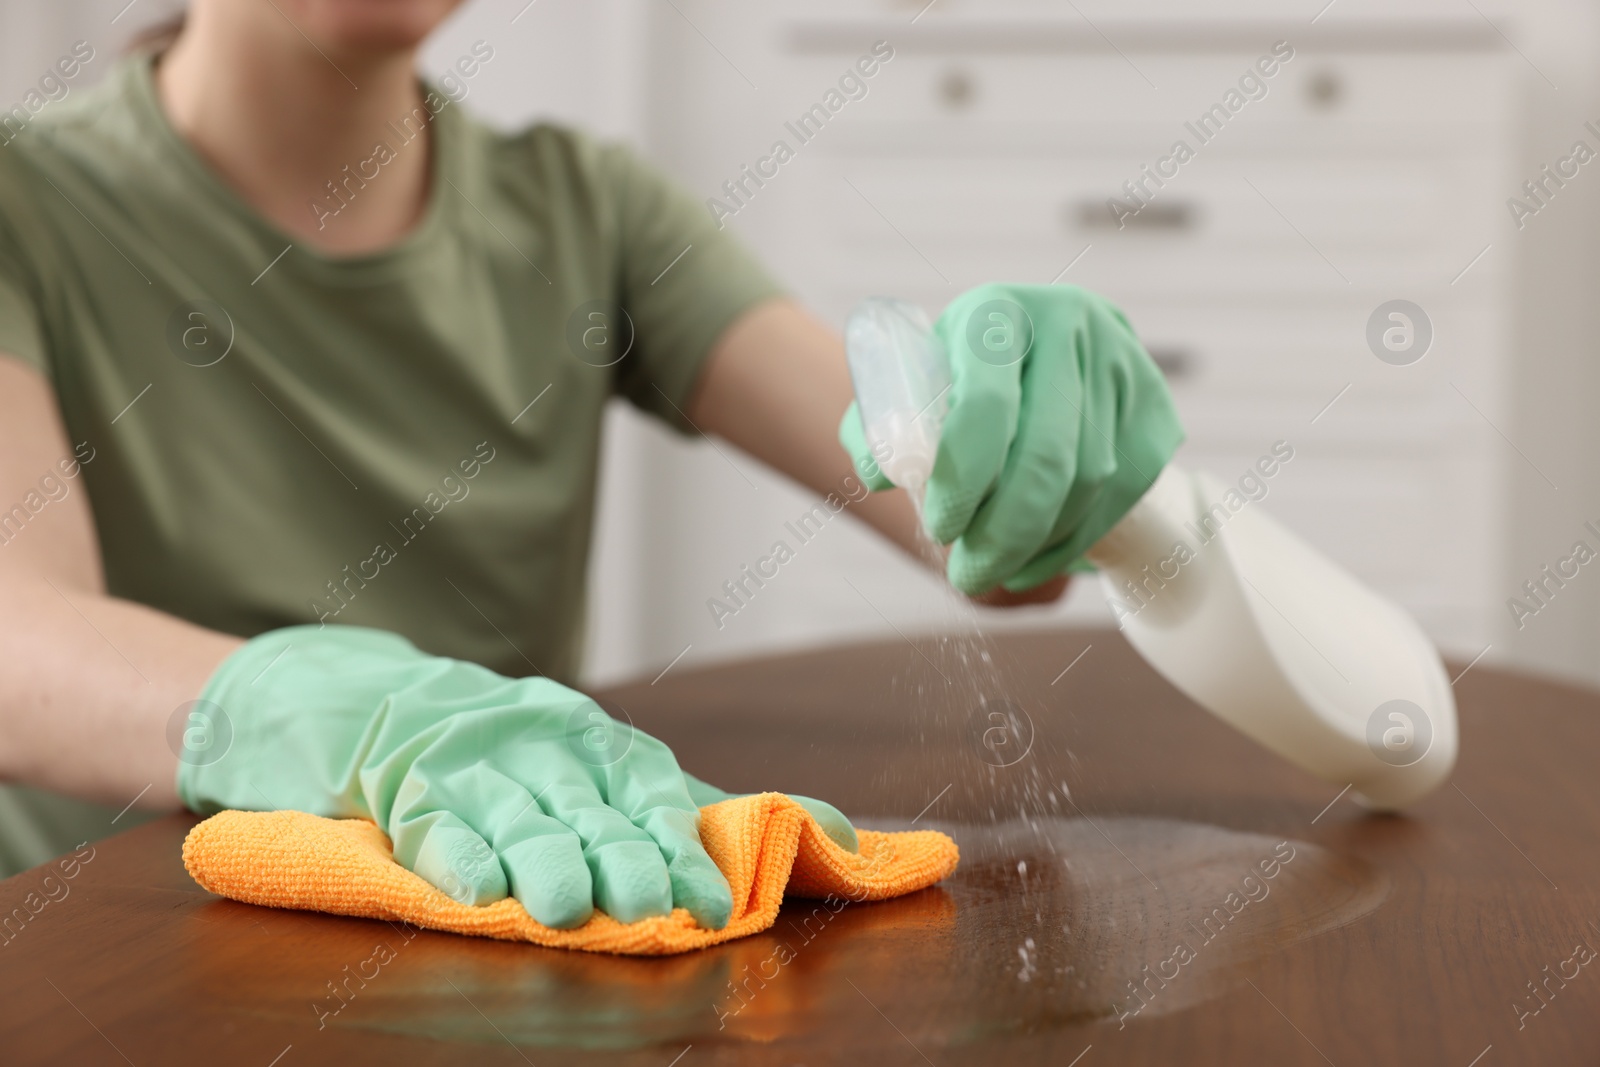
[{"left": 184, "top": 793, "right": 958, "bottom": 955}]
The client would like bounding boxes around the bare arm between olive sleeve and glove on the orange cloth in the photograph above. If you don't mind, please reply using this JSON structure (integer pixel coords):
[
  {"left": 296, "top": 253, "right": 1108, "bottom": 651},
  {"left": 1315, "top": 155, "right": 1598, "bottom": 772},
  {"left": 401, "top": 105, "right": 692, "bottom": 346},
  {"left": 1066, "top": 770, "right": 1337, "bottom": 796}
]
[{"left": 0, "top": 357, "right": 240, "bottom": 806}]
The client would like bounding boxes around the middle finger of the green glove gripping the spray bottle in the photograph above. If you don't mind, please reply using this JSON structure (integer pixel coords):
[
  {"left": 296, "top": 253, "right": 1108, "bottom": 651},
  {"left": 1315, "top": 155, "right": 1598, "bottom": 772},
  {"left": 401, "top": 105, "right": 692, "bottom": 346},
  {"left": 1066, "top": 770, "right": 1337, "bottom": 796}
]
[{"left": 946, "top": 356, "right": 1093, "bottom": 593}]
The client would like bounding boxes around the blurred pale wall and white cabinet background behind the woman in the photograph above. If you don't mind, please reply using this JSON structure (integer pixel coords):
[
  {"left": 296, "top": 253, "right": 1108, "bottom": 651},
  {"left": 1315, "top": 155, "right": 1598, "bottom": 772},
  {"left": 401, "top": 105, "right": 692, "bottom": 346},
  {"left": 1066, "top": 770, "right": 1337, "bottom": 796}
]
[{"left": 12, "top": 0, "right": 1600, "bottom": 694}]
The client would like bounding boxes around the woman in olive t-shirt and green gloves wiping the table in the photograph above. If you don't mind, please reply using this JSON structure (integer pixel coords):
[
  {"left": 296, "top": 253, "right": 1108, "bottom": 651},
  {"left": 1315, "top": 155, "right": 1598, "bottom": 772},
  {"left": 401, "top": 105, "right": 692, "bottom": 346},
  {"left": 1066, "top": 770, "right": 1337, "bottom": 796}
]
[{"left": 0, "top": 0, "right": 1181, "bottom": 926}]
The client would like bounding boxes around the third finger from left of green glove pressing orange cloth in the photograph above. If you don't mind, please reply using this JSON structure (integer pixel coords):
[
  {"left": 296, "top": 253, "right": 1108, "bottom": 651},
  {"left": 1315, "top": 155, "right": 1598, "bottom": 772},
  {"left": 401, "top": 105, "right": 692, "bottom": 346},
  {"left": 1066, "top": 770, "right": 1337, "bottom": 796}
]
[{"left": 539, "top": 779, "right": 675, "bottom": 923}]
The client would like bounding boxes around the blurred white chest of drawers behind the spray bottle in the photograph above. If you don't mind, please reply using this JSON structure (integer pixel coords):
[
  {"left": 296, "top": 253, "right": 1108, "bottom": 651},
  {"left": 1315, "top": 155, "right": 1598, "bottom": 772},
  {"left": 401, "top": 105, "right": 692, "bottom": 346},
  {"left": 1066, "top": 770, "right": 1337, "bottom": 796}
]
[{"left": 604, "top": 0, "right": 1520, "bottom": 681}]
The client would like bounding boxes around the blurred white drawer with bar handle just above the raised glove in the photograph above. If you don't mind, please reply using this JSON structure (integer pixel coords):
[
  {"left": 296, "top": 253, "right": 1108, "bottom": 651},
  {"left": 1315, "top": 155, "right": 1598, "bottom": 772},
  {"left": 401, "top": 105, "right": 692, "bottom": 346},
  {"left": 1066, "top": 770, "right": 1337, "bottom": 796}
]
[{"left": 813, "top": 154, "right": 1504, "bottom": 271}]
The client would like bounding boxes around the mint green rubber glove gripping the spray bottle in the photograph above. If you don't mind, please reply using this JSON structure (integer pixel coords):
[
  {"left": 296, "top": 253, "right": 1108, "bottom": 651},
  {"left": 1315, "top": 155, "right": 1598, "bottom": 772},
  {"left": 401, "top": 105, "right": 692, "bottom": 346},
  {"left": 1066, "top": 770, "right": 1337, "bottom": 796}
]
[{"left": 838, "top": 285, "right": 1184, "bottom": 595}]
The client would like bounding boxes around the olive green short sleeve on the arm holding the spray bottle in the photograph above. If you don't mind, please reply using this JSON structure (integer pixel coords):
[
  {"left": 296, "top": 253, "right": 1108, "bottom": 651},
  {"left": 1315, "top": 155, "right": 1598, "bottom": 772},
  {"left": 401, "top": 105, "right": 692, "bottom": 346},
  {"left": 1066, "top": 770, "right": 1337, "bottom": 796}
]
[{"left": 605, "top": 147, "right": 782, "bottom": 434}]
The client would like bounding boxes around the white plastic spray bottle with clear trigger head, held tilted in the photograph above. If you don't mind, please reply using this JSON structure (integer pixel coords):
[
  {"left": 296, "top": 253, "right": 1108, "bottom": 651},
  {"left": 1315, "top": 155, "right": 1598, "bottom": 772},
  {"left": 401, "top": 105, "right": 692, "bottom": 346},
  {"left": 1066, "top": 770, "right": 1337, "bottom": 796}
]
[{"left": 845, "top": 299, "right": 1456, "bottom": 809}]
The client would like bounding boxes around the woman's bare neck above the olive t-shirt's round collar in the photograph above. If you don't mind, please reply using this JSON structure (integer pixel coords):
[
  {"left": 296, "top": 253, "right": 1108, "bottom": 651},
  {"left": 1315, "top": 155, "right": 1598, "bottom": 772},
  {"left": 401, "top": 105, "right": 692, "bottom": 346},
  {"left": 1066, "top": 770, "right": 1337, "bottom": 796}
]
[{"left": 157, "top": 3, "right": 432, "bottom": 254}]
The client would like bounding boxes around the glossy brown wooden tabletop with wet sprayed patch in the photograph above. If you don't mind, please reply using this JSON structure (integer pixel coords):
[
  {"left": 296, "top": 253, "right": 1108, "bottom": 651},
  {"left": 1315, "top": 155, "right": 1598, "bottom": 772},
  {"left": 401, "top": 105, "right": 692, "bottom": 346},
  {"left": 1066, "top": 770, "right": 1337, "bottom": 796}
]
[{"left": 0, "top": 630, "right": 1600, "bottom": 1067}]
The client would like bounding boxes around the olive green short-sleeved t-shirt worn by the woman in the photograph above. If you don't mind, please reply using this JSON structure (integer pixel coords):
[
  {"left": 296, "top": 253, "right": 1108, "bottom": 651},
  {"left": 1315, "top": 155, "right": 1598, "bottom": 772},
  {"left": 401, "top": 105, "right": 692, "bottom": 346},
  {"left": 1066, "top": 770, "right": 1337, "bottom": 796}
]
[{"left": 0, "top": 58, "right": 776, "bottom": 681}]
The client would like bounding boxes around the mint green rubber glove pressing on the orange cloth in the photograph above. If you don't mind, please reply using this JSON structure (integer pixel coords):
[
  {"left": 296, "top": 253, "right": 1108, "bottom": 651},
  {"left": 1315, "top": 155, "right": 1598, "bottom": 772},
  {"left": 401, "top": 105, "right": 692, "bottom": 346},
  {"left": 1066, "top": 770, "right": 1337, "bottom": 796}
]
[{"left": 178, "top": 625, "right": 843, "bottom": 929}]
